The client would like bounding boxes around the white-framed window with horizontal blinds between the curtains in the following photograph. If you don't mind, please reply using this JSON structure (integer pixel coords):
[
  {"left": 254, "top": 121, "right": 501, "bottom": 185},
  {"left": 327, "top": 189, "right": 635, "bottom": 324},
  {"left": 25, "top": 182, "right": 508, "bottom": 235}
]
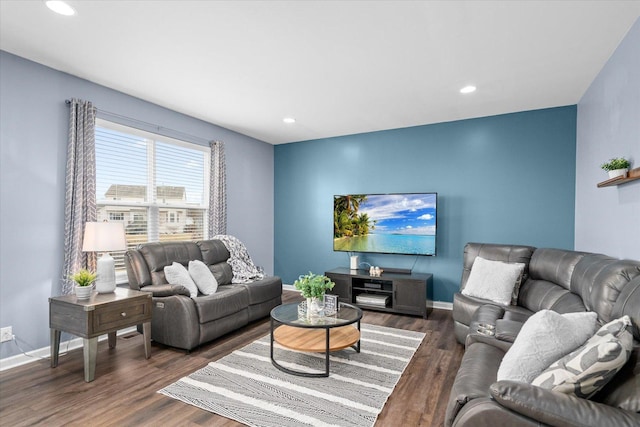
[{"left": 96, "top": 119, "right": 210, "bottom": 275}]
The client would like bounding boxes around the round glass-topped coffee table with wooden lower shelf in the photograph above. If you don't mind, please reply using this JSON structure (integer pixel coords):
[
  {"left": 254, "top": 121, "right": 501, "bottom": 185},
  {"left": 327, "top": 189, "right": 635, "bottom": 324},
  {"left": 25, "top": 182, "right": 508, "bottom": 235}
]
[{"left": 271, "top": 303, "right": 362, "bottom": 377}]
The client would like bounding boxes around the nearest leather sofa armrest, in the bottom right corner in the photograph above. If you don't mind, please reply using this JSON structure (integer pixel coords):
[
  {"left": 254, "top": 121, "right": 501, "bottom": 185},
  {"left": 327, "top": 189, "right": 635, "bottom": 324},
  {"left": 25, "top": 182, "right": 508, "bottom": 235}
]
[{"left": 489, "top": 381, "right": 640, "bottom": 427}]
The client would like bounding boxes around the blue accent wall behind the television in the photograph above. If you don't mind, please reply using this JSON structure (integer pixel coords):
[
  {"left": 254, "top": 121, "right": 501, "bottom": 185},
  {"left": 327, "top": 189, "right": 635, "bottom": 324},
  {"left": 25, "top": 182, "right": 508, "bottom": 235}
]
[{"left": 274, "top": 106, "right": 576, "bottom": 302}]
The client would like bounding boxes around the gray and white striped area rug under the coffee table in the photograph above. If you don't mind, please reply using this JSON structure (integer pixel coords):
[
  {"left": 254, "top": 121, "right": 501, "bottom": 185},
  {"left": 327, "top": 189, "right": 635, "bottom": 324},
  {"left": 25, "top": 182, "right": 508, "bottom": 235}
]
[{"left": 159, "top": 324, "right": 425, "bottom": 427}]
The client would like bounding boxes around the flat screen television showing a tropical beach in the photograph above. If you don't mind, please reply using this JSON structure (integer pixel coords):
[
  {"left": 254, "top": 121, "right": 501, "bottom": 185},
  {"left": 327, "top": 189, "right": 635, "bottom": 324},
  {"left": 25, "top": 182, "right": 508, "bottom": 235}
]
[{"left": 333, "top": 193, "right": 438, "bottom": 256}]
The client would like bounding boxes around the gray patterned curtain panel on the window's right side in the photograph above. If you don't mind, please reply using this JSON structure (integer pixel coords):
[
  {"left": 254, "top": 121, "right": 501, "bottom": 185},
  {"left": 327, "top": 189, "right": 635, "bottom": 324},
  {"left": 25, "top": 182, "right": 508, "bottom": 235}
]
[{"left": 209, "top": 141, "right": 227, "bottom": 238}]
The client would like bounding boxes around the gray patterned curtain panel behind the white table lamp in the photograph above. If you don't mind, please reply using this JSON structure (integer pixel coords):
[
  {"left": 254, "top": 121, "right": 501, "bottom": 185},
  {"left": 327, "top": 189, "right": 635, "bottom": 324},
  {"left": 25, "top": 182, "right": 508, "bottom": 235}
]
[{"left": 62, "top": 99, "right": 96, "bottom": 295}]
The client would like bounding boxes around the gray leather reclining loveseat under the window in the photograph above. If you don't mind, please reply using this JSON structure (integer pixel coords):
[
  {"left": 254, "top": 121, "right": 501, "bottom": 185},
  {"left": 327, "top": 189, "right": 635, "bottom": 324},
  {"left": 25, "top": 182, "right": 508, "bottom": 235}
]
[{"left": 125, "top": 240, "right": 282, "bottom": 350}]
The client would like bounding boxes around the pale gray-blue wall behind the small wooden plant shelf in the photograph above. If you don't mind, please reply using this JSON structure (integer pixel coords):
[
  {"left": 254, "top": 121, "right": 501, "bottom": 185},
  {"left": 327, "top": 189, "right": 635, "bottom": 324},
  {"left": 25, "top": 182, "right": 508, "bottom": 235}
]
[{"left": 575, "top": 20, "right": 640, "bottom": 259}]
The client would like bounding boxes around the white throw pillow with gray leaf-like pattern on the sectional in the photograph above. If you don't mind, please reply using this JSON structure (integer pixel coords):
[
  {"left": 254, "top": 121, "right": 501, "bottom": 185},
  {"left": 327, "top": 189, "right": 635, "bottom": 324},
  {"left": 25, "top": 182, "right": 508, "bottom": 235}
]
[{"left": 531, "top": 316, "right": 633, "bottom": 399}]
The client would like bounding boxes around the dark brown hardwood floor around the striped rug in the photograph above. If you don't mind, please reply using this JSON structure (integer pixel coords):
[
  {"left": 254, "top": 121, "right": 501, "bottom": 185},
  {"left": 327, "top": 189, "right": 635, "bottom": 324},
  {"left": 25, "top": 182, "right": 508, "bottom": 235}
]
[{"left": 0, "top": 291, "right": 463, "bottom": 426}]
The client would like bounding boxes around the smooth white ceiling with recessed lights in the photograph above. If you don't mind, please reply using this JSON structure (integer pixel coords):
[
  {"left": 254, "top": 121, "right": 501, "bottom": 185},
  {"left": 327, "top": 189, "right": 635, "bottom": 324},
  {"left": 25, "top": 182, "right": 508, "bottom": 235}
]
[{"left": 0, "top": 0, "right": 640, "bottom": 144}]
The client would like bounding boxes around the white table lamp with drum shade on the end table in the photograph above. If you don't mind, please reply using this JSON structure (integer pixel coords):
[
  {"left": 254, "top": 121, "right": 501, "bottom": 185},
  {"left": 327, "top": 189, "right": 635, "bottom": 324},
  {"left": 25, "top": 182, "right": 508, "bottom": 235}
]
[{"left": 82, "top": 222, "right": 127, "bottom": 294}]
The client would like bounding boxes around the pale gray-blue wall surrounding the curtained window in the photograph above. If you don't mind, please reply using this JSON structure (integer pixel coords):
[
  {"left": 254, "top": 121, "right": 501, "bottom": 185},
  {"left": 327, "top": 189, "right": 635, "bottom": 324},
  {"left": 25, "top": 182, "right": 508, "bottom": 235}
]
[{"left": 0, "top": 52, "right": 274, "bottom": 358}]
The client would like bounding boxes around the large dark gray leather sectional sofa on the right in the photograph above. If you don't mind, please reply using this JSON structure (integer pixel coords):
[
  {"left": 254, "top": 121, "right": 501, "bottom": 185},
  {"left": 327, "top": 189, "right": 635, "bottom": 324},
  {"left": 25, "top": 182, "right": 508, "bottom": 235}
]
[{"left": 445, "top": 243, "right": 640, "bottom": 427}]
